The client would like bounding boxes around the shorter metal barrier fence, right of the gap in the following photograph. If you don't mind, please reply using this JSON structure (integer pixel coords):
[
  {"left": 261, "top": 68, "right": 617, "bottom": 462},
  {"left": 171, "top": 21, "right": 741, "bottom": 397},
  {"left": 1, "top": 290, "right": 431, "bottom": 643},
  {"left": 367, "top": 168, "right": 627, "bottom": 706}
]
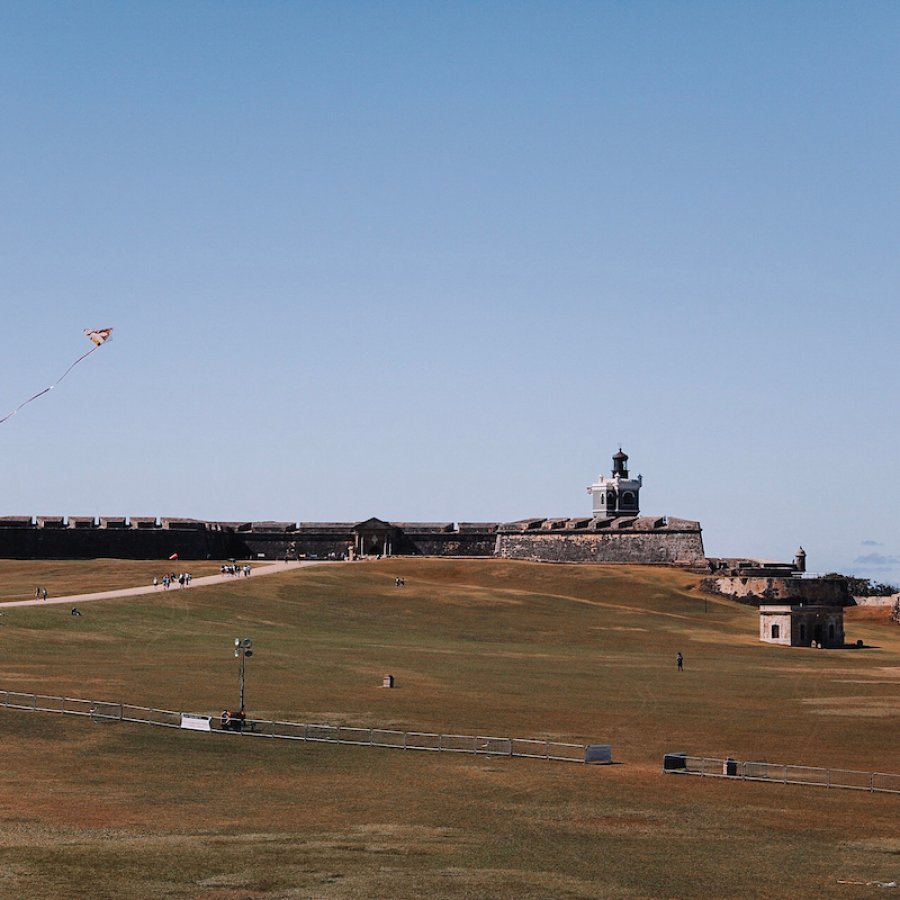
[{"left": 663, "top": 753, "right": 900, "bottom": 794}]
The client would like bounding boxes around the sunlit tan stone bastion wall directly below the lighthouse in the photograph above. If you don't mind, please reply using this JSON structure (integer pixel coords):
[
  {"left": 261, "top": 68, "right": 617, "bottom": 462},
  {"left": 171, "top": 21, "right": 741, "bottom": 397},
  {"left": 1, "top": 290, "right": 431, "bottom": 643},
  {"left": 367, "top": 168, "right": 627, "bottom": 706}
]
[{"left": 496, "top": 527, "right": 705, "bottom": 566}]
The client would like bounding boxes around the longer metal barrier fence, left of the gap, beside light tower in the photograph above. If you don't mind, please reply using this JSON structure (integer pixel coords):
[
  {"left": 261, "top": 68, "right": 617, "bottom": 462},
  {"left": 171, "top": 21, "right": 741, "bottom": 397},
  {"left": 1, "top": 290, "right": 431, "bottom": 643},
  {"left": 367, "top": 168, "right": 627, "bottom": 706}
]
[{"left": 0, "top": 691, "right": 586, "bottom": 763}]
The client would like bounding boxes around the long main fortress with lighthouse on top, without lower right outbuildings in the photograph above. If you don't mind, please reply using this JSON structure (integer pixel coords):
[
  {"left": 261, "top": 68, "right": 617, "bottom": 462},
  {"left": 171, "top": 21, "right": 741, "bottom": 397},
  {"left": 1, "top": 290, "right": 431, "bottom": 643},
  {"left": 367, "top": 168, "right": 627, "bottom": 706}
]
[{"left": 0, "top": 449, "right": 709, "bottom": 571}]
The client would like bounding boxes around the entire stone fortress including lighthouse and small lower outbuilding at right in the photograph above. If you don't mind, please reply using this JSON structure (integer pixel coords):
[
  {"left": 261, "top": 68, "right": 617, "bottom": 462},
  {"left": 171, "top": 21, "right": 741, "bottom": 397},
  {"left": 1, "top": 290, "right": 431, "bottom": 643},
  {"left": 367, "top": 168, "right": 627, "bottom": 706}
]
[{"left": 0, "top": 448, "right": 864, "bottom": 647}]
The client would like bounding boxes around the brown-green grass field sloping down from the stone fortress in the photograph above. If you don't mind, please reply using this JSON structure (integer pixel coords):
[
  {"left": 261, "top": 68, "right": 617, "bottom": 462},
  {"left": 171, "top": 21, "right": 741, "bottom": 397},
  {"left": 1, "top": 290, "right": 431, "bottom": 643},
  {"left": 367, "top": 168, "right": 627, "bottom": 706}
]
[{"left": 0, "top": 559, "right": 900, "bottom": 898}]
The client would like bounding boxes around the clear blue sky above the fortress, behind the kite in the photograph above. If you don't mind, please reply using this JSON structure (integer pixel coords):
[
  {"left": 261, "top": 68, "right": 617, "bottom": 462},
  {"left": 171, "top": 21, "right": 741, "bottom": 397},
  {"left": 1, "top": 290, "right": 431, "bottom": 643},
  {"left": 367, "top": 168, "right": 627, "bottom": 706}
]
[{"left": 0, "top": 0, "right": 900, "bottom": 580}]
